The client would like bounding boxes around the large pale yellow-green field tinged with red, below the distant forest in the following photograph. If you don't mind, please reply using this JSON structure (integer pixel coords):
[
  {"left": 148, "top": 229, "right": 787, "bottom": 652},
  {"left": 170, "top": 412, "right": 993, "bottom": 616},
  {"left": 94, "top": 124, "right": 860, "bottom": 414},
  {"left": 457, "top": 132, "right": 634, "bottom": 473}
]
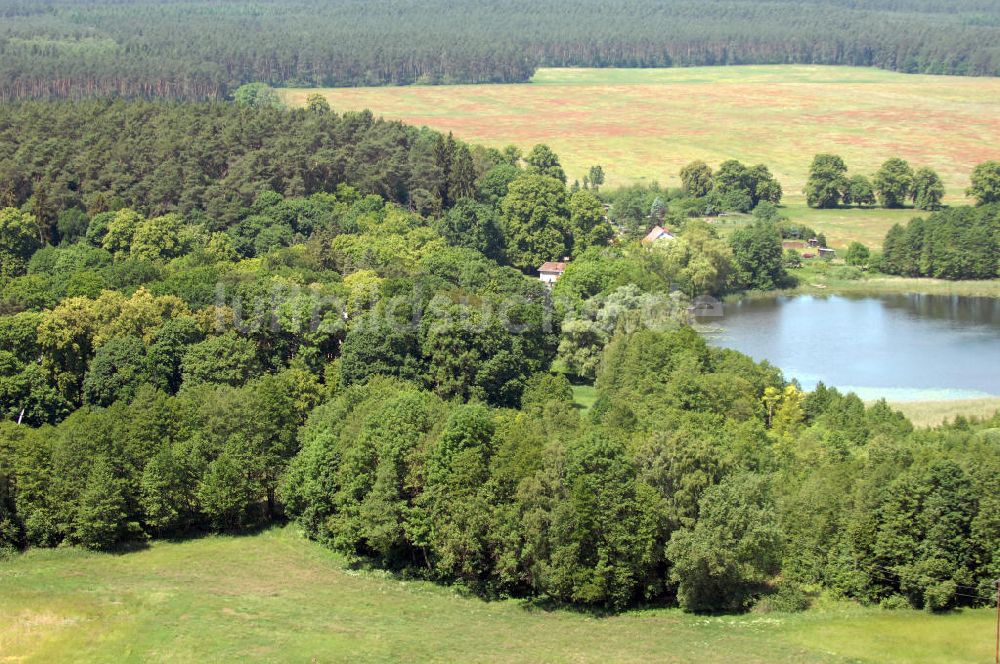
[{"left": 282, "top": 65, "right": 1000, "bottom": 204}]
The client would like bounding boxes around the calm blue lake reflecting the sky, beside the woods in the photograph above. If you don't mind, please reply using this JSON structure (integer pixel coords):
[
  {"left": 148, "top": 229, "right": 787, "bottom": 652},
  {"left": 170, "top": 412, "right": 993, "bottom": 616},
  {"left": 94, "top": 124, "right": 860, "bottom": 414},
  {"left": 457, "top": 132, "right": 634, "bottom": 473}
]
[{"left": 699, "top": 295, "right": 1000, "bottom": 401}]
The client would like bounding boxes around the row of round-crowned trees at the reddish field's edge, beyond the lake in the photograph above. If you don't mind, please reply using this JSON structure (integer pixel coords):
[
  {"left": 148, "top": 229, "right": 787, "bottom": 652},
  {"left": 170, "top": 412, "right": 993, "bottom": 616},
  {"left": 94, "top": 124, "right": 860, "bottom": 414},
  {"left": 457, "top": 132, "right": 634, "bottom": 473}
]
[{"left": 804, "top": 154, "right": 944, "bottom": 210}]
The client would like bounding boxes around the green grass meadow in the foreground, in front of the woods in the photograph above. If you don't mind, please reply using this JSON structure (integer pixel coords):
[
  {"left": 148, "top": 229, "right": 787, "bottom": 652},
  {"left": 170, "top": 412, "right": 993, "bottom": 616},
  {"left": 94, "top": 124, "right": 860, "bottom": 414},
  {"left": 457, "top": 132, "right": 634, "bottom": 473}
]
[{"left": 0, "top": 527, "right": 993, "bottom": 663}]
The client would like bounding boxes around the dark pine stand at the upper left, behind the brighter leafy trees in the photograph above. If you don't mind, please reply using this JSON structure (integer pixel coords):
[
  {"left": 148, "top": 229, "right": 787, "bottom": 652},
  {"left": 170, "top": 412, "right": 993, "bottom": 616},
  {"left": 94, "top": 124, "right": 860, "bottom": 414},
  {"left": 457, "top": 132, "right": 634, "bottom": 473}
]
[{"left": 0, "top": 101, "right": 479, "bottom": 219}]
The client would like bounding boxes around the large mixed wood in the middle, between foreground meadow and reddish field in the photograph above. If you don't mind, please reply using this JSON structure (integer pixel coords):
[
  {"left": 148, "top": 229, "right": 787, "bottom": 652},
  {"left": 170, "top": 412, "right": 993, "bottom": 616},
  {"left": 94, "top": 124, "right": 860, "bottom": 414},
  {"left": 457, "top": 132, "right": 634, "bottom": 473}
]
[{"left": 0, "top": 100, "right": 1000, "bottom": 611}]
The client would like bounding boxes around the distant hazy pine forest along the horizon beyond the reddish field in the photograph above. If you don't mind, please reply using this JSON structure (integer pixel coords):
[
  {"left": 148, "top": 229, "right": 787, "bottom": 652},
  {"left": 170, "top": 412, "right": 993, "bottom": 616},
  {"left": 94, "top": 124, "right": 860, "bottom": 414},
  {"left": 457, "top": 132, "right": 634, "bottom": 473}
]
[{"left": 0, "top": 0, "right": 1000, "bottom": 100}]
